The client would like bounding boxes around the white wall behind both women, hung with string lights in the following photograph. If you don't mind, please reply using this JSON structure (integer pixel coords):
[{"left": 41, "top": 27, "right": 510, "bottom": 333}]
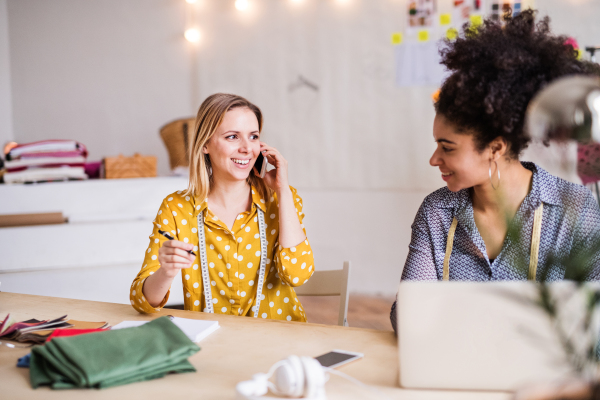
[{"left": 0, "top": 0, "right": 600, "bottom": 293}]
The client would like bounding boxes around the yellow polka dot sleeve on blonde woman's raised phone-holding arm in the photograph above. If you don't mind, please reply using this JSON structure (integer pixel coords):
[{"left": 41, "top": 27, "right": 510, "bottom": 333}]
[{"left": 274, "top": 186, "right": 315, "bottom": 286}]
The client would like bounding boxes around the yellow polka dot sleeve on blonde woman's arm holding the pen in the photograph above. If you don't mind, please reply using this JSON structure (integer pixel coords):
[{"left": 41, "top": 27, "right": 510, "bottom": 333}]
[{"left": 129, "top": 199, "right": 172, "bottom": 313}]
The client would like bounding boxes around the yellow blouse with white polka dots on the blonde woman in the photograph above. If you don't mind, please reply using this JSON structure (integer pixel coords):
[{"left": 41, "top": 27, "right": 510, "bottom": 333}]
[{"left": 130, "top": 187, "right": 314, "bottom": 322}]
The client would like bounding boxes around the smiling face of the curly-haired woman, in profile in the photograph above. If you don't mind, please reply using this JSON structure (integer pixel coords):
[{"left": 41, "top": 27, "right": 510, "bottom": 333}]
[{"left": 429, "top": 114, "right": 492, "bottom": 192}]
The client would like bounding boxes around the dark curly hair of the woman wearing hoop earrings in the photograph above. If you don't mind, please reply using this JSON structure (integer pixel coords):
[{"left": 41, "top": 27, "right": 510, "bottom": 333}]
[{"left": 435, "top": 10, "right": 592, "bottom": 158}]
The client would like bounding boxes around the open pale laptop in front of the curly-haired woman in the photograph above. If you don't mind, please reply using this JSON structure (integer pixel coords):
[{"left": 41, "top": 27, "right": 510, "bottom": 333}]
[{"left": 396, "top": 282, "right": 598, "bottom": 391}]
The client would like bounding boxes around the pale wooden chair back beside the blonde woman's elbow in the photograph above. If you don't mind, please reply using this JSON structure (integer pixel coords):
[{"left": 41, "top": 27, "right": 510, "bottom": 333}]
[{"left": 294, "top": 261, "right": 350, "bottom": 326}]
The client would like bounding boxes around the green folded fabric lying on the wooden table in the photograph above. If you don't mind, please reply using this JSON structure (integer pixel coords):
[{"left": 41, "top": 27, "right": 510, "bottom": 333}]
[{"left": 29, "top": 317, "right": 200, "bottom": 389}]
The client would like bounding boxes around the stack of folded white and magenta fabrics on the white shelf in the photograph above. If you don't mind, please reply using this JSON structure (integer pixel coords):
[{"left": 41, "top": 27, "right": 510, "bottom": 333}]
[{"left": 4, "top": 140, "right": 87, "bottom": 183}]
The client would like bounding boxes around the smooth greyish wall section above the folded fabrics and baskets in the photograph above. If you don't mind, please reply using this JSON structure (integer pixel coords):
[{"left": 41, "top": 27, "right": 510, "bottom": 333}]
[{"left": 8, "top": 0, "right": 192, "bottom": 172}]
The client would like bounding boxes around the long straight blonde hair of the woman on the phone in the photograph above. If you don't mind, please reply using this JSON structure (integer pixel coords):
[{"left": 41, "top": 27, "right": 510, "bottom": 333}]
[{"left": 185, "top": 93, "right": 271, "bottom": 201}]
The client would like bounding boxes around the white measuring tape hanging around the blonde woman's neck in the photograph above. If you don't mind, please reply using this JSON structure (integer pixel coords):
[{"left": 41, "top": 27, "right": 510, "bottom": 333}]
[{"left": 197, "top": 207, "right": 267, "bottom": 318}]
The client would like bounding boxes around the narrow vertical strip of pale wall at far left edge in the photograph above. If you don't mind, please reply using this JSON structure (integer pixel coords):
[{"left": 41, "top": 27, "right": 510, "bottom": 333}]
[{"left": 0, "top": 0, "right": 13, "bottom": 147}]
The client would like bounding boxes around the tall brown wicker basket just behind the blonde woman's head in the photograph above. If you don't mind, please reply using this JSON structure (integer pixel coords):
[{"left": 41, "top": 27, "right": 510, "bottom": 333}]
[{"left": 160, "top": 118, "right": 195, "bottom": 170}]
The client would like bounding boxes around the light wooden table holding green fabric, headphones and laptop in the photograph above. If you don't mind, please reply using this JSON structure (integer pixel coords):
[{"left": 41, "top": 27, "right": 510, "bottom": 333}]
[{"left": 0, "top": 292, "right": 510, "bottom": 400}]
